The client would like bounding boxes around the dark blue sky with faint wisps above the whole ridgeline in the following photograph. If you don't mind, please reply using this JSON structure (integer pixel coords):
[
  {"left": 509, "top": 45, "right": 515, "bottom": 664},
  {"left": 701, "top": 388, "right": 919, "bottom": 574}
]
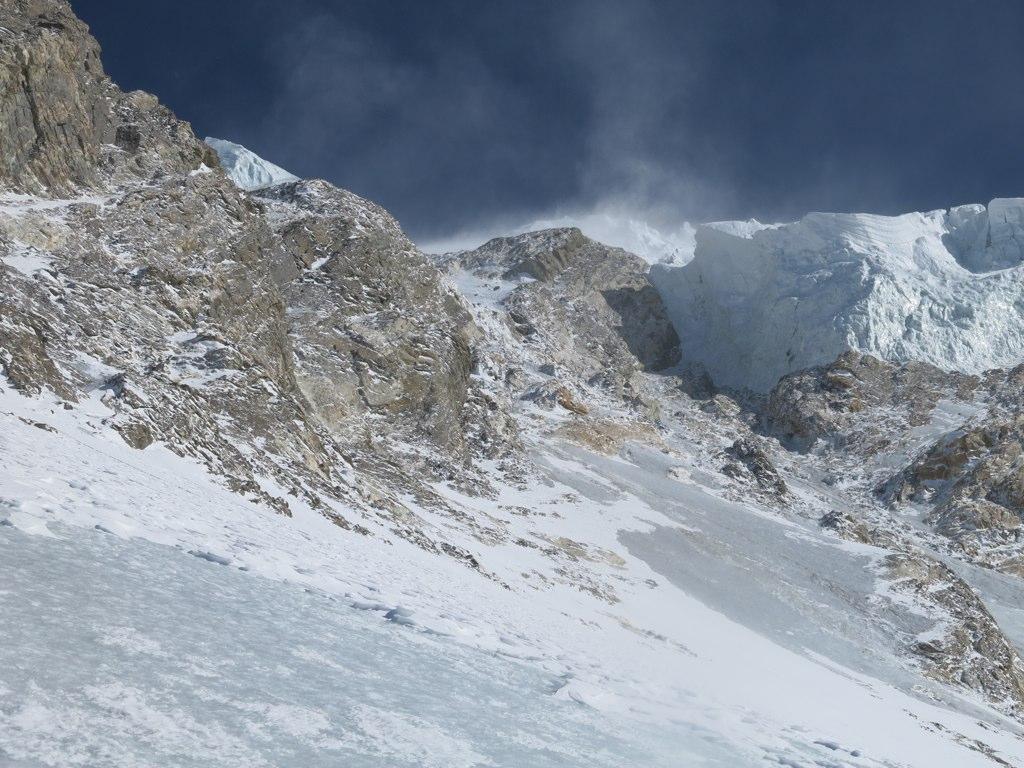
[{"left": 72, "top": 0, "right": 1024, "bottom": 239}]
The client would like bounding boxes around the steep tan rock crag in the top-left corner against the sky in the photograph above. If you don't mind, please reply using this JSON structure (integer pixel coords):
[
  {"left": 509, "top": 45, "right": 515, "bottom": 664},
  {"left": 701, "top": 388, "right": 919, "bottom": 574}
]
[{"left": 0, "top": 0, "right": 217, "bottom": 196}]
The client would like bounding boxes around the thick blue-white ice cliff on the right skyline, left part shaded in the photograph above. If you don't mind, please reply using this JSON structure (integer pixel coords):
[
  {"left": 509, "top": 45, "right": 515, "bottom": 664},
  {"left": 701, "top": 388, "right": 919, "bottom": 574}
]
[{"left": 651, "top": 199, "right": 1024, "bottom": 390}]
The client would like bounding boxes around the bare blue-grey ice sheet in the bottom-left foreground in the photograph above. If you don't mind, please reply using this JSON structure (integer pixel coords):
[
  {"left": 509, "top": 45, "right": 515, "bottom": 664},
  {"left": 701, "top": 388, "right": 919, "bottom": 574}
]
[{"left": 0, "top": 526, "right": 688, "bottom": 768}]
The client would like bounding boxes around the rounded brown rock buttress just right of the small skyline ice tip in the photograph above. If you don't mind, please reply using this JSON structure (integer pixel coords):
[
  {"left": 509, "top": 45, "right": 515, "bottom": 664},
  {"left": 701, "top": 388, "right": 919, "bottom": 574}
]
[{"left": 254, "top": 181, "right": 498, "bottom": 460}]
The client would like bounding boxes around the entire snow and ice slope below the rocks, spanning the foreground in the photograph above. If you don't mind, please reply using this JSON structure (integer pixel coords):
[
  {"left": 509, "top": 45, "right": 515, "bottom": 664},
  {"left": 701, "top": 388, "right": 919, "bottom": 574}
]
[{"left": 0, "top": 376, "right": 1024, "bottom": 768}]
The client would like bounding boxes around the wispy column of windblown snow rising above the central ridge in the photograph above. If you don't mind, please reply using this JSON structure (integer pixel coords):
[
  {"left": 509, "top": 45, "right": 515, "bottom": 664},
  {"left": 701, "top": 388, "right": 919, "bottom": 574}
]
[{"left": 420, "top": 3, "right": 745, "bottom": 265}]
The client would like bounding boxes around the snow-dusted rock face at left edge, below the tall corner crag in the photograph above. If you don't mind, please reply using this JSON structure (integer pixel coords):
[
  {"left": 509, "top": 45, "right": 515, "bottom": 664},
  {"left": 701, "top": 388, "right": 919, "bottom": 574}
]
[{"left": 0, "top": 167, "right": 344, "bottom": 518}]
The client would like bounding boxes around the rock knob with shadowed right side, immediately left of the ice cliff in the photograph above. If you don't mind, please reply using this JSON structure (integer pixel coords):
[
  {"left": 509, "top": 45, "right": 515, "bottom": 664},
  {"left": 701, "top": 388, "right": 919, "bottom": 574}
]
[{"left": 438, "top": 228, "right": 679, "bottom": 460}]
